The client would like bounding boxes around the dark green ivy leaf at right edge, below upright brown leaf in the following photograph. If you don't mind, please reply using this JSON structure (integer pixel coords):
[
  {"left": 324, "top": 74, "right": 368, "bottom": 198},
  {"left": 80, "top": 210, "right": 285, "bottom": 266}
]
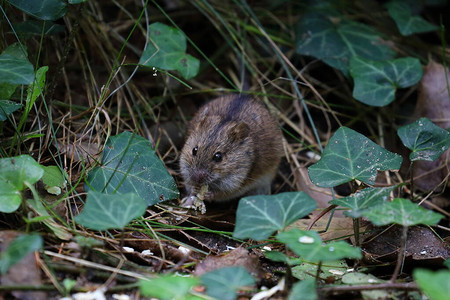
[{"left": 397, "top": 118, "right": 450, "bottom": 161}]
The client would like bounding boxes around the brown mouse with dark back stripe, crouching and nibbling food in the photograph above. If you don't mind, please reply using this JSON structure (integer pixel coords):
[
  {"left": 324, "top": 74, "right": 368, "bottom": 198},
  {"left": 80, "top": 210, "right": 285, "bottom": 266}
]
[{"left": 180, "top": 94, "right": 283, "bottom": 201}]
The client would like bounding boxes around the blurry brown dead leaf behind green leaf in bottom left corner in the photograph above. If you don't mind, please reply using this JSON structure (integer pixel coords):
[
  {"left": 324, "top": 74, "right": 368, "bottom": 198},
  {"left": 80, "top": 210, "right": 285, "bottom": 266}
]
[{"left": 0, "top": 230, "right": 47, "bottom": 300}]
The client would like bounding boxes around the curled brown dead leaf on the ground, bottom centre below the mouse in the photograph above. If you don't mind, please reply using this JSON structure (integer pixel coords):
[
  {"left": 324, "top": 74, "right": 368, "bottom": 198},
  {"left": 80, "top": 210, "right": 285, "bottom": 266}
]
[{"left": 194, "top": 247, "right": 263, "bottom": 278}]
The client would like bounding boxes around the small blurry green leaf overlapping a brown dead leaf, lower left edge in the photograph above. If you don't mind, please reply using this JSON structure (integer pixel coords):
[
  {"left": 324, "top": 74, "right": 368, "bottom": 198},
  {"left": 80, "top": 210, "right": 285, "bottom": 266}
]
[{"left": 0, "top": 233, "right": 42, "bottom": 274}]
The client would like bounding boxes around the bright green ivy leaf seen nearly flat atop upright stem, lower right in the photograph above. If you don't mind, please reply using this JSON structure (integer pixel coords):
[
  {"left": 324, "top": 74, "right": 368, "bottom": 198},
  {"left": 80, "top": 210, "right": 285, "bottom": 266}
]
[{"left": 363, "top": 198, "right": 443, "bottom": 226}]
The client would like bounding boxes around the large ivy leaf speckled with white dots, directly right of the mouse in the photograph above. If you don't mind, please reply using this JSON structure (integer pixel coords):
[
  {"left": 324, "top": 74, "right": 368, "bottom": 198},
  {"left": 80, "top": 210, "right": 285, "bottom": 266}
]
[{"left": 308, "top": 127, "right": 402, "bottom": 187}]
